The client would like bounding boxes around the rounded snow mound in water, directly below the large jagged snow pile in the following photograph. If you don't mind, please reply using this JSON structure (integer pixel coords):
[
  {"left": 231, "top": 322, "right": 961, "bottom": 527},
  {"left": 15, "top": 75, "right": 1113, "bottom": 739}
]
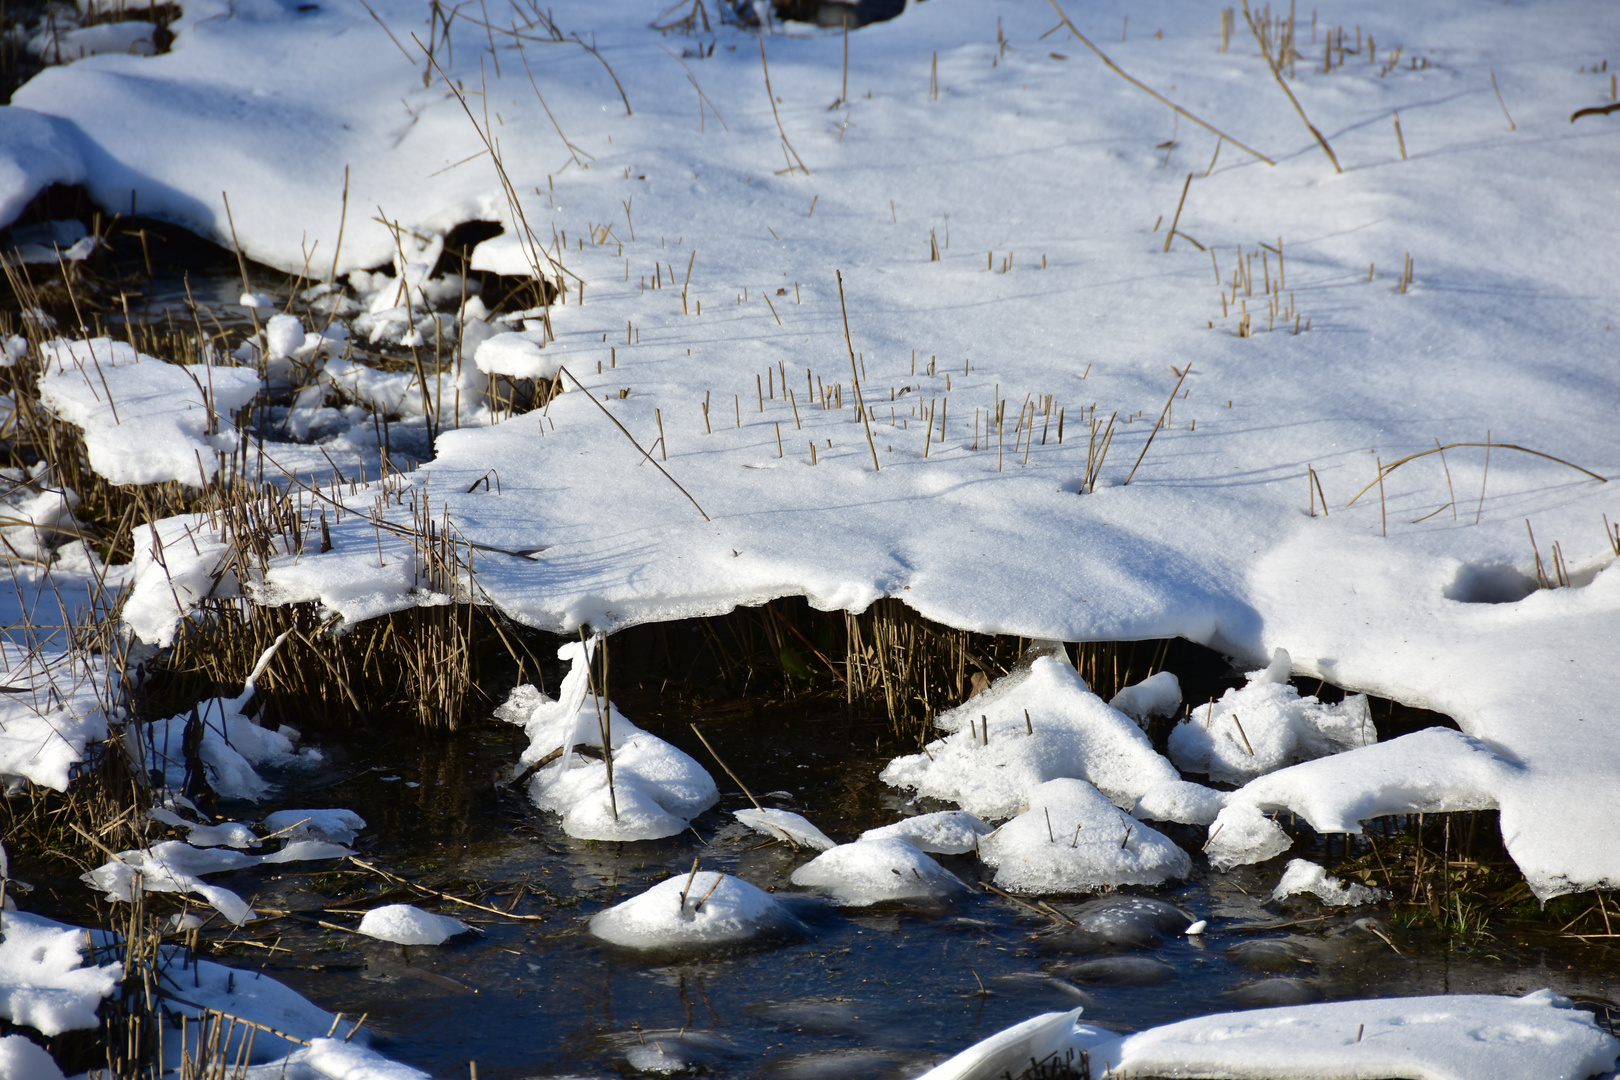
[{"left": 978, "top": 777, "right": 1192, "bottom": 892}]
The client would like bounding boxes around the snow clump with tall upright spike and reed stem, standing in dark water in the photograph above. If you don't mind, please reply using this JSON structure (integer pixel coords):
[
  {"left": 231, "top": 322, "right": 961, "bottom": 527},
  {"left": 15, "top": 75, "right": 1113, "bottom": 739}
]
[{"left": 496, "top": 641, "right": 719, "bottom": 840}]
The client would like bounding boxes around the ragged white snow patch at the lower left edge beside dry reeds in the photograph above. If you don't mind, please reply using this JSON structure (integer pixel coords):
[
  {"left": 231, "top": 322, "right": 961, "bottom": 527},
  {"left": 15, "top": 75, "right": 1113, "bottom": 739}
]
[{"left": 0, "top": 910, "right": 123, "bottom": 1036}]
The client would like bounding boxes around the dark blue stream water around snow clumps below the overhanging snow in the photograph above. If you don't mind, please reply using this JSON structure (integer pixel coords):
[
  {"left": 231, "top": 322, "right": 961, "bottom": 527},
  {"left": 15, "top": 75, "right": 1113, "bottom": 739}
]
[{"left": 215, "top": 683, "right": 1615, "bottom": 1077}]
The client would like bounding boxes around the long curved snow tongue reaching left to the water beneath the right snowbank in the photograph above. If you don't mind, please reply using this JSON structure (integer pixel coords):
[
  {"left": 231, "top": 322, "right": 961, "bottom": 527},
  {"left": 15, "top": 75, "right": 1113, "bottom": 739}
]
[{"left": 1205, "top": 727, "right": 1503, "bottom": 870}]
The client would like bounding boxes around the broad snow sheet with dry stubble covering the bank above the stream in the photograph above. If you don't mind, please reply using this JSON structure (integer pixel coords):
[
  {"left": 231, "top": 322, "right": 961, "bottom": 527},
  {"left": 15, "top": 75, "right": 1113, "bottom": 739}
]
[{"left": 19, "top": 0, "right": 1620, "bottom": 897}]
